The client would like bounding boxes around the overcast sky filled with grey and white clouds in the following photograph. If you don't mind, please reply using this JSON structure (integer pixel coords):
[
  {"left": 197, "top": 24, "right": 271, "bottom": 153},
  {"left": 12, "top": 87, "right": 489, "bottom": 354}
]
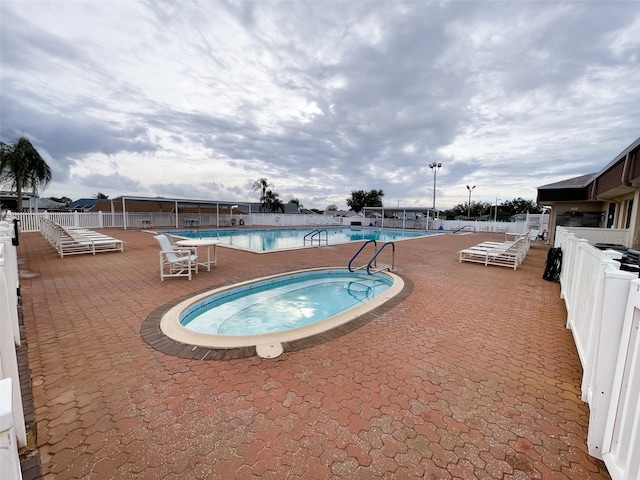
[{"left": 0, "top": 0, "right": 640, "bottom": 208}]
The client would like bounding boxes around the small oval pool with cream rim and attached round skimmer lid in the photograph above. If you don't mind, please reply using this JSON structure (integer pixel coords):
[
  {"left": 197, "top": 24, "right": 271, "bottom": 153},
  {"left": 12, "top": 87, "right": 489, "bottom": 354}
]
[{"left": 160, "top": 268, "right": 404, "bottom": 358}]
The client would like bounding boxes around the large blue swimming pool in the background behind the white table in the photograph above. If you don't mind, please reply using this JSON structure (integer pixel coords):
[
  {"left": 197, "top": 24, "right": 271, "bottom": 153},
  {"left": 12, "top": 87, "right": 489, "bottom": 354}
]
[{"left": 162, "top": 227, "right": 442, "bottom": 252}]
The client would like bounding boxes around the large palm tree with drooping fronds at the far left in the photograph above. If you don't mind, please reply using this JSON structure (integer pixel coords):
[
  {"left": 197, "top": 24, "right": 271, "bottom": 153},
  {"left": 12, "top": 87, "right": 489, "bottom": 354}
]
[{"left": 0, "top": 137, "right": 51, "bottom": 211}]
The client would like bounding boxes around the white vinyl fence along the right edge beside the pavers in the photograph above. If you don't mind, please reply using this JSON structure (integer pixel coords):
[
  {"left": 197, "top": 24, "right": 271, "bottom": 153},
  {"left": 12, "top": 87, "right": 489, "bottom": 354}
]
[{"left": 554, "top": 227, "right": 640, "bottom": 480}]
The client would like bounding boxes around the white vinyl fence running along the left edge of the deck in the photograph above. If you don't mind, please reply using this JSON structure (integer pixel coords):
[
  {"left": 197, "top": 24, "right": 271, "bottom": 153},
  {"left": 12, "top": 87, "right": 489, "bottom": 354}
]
[{"left": 0, "top": 222, "right": 27, "bottom": 480}]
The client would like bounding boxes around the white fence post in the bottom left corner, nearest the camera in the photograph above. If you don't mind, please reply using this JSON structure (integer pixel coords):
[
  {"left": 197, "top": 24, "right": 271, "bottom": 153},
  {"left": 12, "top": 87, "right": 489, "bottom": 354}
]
[{"left": 0, "top": 378, "right": 22, "bottom": 480}]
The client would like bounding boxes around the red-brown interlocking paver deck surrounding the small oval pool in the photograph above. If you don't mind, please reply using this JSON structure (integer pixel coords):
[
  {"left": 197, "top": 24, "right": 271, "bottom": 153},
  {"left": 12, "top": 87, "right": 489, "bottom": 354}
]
[{"left": 19, "top": 230, "right": 609, "bottom": 479}]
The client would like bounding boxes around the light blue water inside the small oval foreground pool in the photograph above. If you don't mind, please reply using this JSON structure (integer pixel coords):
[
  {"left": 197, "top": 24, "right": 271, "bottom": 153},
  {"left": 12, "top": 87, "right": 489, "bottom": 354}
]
[{"left": 179, "top": 269, "right": 393, "bottom": 335}]
